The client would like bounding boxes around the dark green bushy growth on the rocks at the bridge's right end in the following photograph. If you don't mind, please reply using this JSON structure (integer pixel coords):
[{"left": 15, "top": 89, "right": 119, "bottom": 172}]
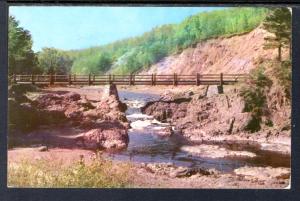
[{"left": 240, "top": 67, "right": 272, "bottom": 132}]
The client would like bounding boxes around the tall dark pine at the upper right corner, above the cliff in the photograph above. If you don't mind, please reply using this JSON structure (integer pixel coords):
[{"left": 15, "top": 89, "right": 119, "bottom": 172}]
[{"left": 263, "top": 8, "right": 291, "bottom": 61}]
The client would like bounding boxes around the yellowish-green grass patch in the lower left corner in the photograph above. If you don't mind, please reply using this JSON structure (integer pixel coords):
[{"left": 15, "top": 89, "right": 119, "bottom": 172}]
[{"left": 8, "top": 153, "right": 131, "bottom": 188}]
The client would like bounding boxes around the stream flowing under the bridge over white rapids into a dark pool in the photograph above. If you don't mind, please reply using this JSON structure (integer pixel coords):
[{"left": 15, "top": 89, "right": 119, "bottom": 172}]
[{"left": 109, "top": 91, "right": 290, "bottom": 172}]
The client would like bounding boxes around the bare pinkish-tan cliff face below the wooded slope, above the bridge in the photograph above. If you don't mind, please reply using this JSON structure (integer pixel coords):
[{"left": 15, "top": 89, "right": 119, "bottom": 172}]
[{"left": 142, "top": 28, "right": 287, "bottom": 74}]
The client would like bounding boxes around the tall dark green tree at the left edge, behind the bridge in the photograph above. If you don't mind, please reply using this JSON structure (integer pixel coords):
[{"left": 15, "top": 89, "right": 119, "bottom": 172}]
[{"left": 8, "top": 16, "right": 39, "bottom": 74}]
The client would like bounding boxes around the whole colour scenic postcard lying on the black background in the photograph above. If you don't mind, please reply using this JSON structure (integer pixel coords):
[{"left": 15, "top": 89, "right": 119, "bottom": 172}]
[{"left": 7, "top": 5, "right": 292, "bottom": 189}]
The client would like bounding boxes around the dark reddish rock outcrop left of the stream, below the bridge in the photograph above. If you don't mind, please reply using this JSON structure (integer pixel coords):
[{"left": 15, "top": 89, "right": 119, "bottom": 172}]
[{"left": 9, "top": 83, "right": 129, "bottom": 150}]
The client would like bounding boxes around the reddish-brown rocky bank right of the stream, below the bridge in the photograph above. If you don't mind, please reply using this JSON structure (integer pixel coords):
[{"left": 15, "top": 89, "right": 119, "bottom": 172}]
[{"left": 142, "top": 86, "right": 291, "bottom": 153}]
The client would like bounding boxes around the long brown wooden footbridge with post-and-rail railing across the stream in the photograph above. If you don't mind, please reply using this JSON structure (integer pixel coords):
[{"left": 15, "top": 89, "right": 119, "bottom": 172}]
[{"left": 9, "top": 73, "right": 248, "bottom": 86}]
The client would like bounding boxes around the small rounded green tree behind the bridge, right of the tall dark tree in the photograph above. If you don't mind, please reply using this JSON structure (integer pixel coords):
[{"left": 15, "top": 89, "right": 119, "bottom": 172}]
[{"left": 38, "top": 48, "right": 73, "bottom": 74}]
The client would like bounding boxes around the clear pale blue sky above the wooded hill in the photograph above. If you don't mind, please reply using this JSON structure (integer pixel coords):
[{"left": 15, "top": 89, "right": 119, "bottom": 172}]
[{"left": 9, "top": 6, "right": 222, "bottom": 52}]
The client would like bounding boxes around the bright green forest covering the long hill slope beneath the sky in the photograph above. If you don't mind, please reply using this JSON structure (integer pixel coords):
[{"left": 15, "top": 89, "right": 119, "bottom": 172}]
[{"left": 66, "top": 8, "right": 268, "bottom": 74}]
